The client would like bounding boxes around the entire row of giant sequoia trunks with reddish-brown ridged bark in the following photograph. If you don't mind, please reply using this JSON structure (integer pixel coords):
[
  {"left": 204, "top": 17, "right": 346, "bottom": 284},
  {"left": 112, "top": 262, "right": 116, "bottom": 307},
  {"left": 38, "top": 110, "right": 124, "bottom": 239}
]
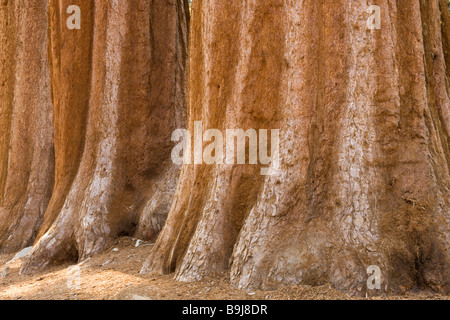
[{"left": 0, "top": 0, "right": 450, "bottom": 294}]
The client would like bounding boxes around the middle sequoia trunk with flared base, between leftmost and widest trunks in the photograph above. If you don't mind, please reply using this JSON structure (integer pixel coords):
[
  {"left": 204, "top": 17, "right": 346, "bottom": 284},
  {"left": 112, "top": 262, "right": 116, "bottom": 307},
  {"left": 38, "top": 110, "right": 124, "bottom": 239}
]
[{"left": 21, "top": 0, "right": 189, "bottom": 273}]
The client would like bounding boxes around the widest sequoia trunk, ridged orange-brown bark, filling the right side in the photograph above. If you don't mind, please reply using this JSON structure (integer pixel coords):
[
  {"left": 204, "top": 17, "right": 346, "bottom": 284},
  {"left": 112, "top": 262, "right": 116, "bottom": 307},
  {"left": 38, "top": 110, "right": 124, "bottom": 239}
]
[{"left": 142, "top": 0, "right": 450, "bottom": 293}]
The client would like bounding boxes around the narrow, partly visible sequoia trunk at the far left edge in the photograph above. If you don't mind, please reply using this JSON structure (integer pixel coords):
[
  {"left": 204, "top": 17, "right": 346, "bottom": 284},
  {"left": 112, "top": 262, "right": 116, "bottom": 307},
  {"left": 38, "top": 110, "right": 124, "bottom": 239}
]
[{"left": 0, "top": 0, "right": 54, "bottom": 253}]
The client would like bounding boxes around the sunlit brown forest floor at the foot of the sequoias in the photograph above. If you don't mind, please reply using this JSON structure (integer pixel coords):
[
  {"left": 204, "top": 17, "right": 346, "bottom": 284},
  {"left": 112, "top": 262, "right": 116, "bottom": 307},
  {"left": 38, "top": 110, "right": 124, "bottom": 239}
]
[{"left": 0, "top": 238, "right": 450, "bottom": 300}]
